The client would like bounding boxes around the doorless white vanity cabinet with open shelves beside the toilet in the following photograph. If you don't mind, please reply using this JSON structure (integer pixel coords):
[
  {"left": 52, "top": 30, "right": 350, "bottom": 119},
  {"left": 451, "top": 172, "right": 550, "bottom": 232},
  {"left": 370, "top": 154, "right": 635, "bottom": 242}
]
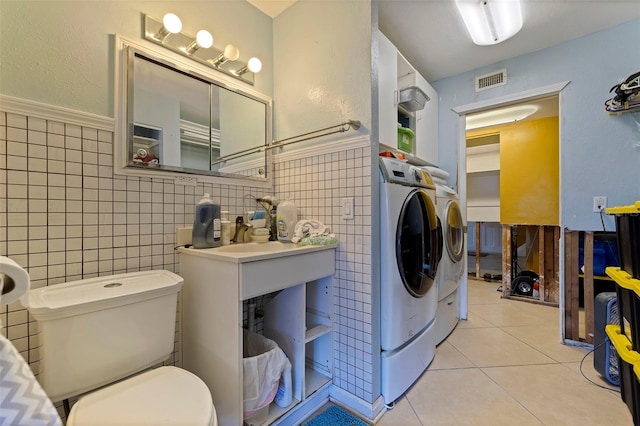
[{"left": 175, "top": 242, "right": 335, "bottom": 426}]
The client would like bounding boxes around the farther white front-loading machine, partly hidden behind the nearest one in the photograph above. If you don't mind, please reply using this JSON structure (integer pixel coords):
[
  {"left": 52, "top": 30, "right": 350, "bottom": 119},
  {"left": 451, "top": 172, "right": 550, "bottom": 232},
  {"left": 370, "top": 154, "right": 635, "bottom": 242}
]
[{"left": 436, "top": 184, "right": 466, "bottom": 344}]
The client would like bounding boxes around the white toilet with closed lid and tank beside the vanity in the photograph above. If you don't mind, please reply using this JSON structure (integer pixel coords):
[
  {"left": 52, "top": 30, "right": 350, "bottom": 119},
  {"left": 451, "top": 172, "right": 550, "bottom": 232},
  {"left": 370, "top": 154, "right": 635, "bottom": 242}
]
[{"left": 28, "top": 271, "right": 217, "bottom": 426}]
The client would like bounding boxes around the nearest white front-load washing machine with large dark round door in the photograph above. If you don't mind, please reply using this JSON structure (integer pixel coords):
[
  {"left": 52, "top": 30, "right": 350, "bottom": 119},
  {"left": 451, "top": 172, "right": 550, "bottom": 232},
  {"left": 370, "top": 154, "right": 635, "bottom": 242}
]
[{"left": 380, "top": 157, "right": 442, "bottom": 404}]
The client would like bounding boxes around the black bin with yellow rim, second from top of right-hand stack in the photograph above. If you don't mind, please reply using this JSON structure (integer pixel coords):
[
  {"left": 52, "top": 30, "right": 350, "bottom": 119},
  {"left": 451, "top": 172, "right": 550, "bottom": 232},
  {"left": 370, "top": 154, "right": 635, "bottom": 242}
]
[{"left": 607, "top": 266, "right": 640, "bottom": 352}]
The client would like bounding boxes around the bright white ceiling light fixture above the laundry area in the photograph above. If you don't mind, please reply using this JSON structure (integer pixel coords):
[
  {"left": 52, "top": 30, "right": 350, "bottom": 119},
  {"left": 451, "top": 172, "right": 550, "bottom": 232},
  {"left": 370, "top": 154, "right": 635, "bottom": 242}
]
[{"left": 456, "top": 0, "right": 522, "bottom": 46}]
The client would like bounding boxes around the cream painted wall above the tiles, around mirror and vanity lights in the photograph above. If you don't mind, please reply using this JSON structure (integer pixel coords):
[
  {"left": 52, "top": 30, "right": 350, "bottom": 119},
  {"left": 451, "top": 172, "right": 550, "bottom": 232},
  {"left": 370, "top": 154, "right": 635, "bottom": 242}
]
[{"left": 0, "top": 0, "right": 273, "bottom": 117}]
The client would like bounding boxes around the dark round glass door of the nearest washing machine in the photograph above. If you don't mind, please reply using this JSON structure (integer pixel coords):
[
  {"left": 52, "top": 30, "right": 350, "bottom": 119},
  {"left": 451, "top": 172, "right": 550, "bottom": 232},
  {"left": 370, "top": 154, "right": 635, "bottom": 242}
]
[{"left": 396, "top": 189, "right": 441, "bottom": 297}]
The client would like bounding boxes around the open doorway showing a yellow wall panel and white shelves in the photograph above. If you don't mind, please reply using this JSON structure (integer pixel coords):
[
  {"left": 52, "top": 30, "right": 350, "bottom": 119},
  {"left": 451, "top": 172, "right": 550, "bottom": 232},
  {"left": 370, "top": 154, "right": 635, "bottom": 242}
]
[{"left": 466, "top": 95, "right": 559, "bottom": 282}]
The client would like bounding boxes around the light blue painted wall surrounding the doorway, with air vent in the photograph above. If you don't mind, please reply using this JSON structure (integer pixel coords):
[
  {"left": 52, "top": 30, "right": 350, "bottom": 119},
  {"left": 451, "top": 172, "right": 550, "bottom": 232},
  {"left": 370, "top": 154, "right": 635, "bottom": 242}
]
[{"left": 432, "top": 20, "right": 640, "bottom": 230}]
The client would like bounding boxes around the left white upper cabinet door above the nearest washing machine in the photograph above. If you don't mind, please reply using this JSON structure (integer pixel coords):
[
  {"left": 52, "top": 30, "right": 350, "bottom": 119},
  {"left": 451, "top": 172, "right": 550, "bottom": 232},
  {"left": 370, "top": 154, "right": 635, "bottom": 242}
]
[{"left": 378, "top": 31, "right": 398, "bottom": 147}]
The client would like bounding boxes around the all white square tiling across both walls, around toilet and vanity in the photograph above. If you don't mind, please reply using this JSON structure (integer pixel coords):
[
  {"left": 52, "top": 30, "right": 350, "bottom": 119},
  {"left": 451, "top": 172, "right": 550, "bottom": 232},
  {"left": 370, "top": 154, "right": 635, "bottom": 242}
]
[{"left": 0, "top": 101, "right": 378, "bottom": 412}]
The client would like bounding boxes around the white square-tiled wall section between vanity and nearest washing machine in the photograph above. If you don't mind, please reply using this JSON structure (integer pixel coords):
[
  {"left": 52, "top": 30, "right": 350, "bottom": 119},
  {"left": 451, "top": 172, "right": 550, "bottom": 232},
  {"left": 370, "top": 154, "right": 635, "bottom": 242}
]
[{"left": 275, "top": 143, "right": 378, "bottom": 402}]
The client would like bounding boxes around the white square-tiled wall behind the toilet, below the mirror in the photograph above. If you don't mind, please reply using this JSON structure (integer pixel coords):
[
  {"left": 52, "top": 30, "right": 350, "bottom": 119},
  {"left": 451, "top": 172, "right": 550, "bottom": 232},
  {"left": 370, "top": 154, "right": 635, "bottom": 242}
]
[{"left": 0, "top": 111, "right": 272, "bottom": 380}]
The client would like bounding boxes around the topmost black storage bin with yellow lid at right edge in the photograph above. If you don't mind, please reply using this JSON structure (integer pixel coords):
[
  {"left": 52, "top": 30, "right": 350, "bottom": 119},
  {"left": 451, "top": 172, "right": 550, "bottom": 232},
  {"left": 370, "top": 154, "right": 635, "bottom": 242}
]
[{"left": 606, "top": 201, "right": 640, "bottom": 280}]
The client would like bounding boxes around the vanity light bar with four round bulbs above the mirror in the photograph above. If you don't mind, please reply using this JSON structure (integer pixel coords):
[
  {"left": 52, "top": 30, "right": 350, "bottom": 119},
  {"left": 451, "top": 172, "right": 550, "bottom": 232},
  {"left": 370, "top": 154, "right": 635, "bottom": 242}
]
[{"left": 144, "top": 13, "right": 262, "bottom": 84}]
